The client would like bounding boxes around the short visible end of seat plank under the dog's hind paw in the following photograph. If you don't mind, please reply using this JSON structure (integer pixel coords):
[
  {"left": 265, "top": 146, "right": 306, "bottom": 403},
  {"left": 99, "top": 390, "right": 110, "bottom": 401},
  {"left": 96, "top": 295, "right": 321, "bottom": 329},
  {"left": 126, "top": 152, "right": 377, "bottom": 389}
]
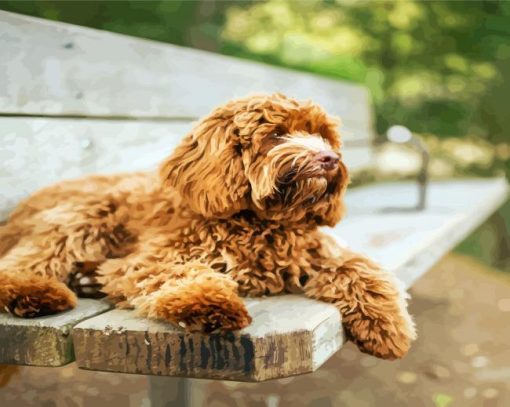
[{"left": 0, "top": 299, "right": 110, "bottom": 366}]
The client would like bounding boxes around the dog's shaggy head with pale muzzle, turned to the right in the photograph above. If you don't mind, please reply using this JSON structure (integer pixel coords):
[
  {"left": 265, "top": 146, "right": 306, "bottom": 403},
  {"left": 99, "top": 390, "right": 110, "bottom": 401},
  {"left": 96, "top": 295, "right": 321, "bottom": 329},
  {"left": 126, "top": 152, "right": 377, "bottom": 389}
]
[{"left": 161, "top": 94, "right": 348, "bottom": 225}]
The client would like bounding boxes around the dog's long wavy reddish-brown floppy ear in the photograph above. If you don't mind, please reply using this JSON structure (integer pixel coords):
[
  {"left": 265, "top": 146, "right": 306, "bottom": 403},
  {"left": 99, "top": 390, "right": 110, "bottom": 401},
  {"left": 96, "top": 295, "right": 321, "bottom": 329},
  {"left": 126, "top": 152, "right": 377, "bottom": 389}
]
[{"left": 160, "top": 116, "right": 249, "bottom": 218}]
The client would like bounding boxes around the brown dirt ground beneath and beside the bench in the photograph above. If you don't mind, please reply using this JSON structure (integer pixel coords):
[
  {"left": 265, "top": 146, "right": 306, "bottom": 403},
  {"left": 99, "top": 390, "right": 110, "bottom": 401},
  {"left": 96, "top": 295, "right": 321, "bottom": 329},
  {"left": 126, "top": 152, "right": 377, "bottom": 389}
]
[{"left": 0, "top": 254, "right": 510, "bottom": 407}]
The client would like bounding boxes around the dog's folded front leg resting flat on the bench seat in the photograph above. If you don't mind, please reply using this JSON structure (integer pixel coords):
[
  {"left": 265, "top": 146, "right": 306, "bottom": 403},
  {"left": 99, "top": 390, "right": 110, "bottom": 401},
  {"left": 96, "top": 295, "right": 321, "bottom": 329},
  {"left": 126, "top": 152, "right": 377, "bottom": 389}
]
[{"left": 98, "top": 251, "right": 251, "bottom": 332}]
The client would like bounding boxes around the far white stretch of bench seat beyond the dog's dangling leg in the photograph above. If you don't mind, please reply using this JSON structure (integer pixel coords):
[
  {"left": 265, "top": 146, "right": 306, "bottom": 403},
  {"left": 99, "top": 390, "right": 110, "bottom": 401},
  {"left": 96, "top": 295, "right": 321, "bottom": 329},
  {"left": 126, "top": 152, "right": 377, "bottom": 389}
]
[{"left": 325, "top": 178, "right": 508, "bottom": 287}]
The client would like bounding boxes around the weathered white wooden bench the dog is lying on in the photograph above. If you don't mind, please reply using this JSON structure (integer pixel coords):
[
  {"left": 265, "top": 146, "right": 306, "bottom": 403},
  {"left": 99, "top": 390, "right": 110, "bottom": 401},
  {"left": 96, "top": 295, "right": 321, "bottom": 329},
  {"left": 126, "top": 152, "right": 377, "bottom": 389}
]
[{"left": 0, "top": 12, "right": 507, "bottom": 405}]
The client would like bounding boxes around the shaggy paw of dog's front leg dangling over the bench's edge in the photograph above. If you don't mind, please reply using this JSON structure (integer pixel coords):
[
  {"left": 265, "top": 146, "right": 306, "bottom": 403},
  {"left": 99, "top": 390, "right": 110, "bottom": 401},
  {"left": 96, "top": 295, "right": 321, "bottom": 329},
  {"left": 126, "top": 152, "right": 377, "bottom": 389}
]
[{"left": 344, "top": 312, "right": 416, "bottom": 360}]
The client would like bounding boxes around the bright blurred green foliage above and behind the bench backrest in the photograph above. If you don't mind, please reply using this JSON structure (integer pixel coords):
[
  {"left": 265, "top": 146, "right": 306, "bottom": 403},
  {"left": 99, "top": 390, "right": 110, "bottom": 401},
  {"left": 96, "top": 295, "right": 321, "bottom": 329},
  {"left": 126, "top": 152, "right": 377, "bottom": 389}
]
[{"left": 223, "top": 0, "right": 510, "bottom": 141}]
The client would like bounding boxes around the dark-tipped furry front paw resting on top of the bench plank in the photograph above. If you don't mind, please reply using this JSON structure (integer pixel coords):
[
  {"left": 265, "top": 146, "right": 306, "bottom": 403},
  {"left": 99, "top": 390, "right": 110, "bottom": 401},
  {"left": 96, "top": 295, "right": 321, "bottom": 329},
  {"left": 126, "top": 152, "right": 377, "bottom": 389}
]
[{"left": 141, "top": 272, "right": 251, "bottom": 333}]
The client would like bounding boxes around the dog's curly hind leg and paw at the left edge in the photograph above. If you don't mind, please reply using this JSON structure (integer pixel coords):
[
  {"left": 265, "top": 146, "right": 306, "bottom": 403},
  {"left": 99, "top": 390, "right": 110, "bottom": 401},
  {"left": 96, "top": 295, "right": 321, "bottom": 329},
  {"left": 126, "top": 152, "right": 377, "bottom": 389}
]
[{"left": 0, "top": 200, "right": 130, "bottom": 317}]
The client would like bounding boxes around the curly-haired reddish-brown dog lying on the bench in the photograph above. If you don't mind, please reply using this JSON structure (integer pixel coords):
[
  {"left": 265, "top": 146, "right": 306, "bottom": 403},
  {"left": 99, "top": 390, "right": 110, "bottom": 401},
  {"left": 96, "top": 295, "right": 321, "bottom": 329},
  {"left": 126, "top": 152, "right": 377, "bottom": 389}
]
[{"left": 0, "top": 95, "right": 415, "bottom": 359}]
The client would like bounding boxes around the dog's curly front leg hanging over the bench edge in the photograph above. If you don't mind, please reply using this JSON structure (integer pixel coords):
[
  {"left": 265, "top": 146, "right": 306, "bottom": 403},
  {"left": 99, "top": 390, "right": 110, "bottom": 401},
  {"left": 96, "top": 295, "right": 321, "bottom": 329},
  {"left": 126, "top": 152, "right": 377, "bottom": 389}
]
[{"left": 305, "top": 252, "right": 416, "bottom": 359}]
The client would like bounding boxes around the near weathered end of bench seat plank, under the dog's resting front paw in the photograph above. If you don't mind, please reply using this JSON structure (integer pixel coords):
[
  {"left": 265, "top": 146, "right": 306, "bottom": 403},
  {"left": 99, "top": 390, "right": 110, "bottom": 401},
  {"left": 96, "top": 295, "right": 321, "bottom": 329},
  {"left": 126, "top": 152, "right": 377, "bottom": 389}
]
[{"left": 73, "top": 295, "right": 342, "bottom": 381}]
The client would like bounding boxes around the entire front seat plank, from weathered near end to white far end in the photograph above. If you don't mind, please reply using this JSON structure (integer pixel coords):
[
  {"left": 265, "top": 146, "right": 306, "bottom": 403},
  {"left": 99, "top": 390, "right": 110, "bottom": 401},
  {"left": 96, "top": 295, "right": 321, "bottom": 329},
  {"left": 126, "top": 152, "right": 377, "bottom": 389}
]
[{"left": 73, "top": 179, "right": 508, "bottom": 381}]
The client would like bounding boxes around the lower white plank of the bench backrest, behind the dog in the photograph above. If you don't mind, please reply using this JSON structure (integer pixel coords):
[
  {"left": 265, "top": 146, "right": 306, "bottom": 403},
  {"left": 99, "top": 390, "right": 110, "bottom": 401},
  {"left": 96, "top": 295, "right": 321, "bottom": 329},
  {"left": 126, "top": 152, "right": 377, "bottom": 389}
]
[{"left": 0, "top": 117, "right": 370, "bottom": 220}]
